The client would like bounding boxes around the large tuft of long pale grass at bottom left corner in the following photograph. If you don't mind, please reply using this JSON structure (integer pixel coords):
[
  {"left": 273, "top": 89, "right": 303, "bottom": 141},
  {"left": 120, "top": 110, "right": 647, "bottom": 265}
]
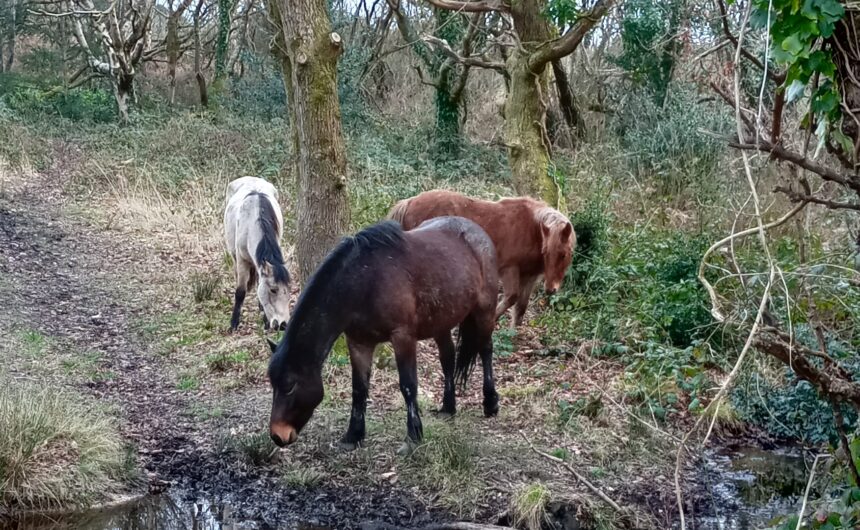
[{"left": 0, "top": 381, "right": 134, "bottom": 509}]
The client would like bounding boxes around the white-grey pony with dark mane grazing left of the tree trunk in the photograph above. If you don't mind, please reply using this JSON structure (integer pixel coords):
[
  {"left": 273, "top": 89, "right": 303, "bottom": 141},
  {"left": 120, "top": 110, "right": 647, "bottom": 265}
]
[{"left": 224, "top": 177, "right": 290, "bottom": 331}]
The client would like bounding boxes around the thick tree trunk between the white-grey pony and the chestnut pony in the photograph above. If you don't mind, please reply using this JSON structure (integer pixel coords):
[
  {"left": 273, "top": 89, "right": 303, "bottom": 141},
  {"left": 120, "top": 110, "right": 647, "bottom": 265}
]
[{"left": 271, "top": 0, "right": 349, "bottom": 283}]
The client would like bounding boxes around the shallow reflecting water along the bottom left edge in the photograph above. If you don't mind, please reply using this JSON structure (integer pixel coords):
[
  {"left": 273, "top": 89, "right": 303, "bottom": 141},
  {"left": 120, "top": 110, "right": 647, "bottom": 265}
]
[{"left": 0, "top": 495, "right": 252, "bottom": 530}]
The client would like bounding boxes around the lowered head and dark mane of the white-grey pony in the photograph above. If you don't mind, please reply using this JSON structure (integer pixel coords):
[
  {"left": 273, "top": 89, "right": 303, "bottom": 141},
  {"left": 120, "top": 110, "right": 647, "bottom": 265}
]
[{"left": 255, "top": 198, "right": 290, "bottom": 329}]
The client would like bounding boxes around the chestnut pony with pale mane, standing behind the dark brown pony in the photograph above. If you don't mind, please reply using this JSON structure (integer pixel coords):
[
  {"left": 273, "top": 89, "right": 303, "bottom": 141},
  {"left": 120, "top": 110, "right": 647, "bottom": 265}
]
[{"left": 388, "top": 190, "right": 576, "bottom": 327}]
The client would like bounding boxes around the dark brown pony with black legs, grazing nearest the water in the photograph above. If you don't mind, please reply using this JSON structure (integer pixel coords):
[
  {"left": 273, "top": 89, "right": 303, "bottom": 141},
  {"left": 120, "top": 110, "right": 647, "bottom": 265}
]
[{"left": 269, "top": 217, "right": 499, "bottom": 448}]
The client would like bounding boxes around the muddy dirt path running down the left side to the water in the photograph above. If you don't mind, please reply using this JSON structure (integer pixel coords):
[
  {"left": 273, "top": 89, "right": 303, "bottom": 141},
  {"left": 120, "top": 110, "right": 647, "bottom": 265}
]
[{"left": 0, "top": 174, "right": 450, "bottom": 528}]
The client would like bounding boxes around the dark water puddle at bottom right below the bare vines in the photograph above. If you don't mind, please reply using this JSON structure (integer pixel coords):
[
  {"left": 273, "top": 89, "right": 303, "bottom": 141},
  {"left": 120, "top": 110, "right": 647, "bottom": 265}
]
[{"left": 695, "top": 447, "right": 809, "bottom": 530}]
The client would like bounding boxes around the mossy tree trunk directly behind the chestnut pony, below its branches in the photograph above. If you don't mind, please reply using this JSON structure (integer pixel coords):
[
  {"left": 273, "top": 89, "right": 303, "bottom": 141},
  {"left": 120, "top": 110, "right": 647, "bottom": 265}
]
[{"left": 505, "top": 50, "right": 559, "bottom": 206}]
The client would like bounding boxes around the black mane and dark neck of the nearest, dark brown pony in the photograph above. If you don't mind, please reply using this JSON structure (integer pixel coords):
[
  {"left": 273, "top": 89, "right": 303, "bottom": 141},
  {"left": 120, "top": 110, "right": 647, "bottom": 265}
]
[{"left": 269, "top": 221, "right": 405, "bottom": 377}]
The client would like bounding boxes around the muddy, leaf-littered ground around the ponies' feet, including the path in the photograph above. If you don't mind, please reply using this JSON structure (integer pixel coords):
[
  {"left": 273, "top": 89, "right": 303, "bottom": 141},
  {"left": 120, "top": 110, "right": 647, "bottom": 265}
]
[{"left": 0, "top": 146, "right": 712, "bottom": 528}]
